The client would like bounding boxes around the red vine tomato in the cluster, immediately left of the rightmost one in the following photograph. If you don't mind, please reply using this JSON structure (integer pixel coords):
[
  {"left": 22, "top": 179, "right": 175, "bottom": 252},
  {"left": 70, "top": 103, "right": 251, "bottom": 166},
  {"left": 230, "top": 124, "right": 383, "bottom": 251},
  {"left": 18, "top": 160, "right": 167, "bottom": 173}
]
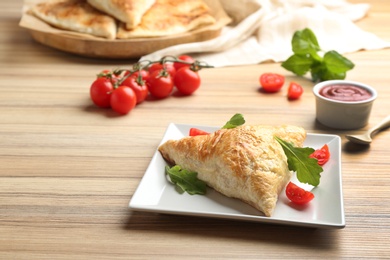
[{"left": 147, "top": 70, "right": 173, "bottom": 99}]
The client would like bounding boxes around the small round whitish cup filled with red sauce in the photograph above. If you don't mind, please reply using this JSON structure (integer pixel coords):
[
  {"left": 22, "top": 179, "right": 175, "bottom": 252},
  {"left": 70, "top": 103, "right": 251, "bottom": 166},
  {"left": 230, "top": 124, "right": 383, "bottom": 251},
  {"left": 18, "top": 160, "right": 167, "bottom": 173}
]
[{"left": 313, "top": 80, "right": 377, "bottom": 129}]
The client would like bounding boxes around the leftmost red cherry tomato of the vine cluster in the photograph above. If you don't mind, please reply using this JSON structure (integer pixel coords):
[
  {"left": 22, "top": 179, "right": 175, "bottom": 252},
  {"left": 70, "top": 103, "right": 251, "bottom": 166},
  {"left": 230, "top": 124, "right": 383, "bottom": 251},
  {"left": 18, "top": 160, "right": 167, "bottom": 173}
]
[{"left": 89, "top": 77, "right": 114, "bottom": 107}]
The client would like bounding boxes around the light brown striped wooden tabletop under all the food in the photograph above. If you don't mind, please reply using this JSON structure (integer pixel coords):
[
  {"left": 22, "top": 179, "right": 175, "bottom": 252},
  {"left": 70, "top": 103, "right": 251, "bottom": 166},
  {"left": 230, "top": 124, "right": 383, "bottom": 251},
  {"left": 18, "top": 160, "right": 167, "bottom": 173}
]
[{"left": 0, "top": 0, "right": 390, "bottom": 259}]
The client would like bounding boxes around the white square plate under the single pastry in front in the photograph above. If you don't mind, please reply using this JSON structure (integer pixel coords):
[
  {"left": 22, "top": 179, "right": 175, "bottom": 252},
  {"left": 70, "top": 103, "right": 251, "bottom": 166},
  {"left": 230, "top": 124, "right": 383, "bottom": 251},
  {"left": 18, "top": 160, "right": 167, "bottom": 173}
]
[{"left": 129, "top": 123, "right": 345, "bottom": 228}]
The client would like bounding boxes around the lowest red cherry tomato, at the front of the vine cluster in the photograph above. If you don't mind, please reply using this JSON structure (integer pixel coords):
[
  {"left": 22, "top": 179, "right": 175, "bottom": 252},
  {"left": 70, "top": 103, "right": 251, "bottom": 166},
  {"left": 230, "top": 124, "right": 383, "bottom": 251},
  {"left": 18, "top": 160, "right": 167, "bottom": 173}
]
[{"left": 110, "top": 86, "right": 137, "bottom": 114}]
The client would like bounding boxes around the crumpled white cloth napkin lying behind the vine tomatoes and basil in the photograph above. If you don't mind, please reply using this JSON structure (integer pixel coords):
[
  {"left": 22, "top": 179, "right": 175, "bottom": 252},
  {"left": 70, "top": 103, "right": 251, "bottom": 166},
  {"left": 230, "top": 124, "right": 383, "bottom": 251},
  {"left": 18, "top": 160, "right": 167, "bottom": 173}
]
[{"left": 140, "top": 0, "right": 390, "bottom": 67}]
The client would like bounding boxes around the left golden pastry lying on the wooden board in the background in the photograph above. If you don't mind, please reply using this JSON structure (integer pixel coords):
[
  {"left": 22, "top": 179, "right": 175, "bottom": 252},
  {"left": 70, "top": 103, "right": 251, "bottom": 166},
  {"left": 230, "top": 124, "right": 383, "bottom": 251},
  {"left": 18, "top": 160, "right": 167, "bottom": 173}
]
[{"left": 31, "top": 0, "right": 117, "bottom": 39}]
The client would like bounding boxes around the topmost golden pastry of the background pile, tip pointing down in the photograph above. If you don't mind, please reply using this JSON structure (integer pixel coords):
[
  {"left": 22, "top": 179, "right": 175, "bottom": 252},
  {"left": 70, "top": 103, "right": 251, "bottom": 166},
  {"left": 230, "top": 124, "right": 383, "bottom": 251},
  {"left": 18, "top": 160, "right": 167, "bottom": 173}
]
[{"left": 87, "top": 0, "right": 156, "bottom": 29}]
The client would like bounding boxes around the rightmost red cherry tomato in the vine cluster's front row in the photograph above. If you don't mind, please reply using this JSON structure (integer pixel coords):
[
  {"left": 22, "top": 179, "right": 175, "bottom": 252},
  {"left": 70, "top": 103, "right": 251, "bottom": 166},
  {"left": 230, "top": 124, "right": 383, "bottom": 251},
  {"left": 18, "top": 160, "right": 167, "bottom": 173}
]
[{"left": 174, "top": 67, "right": 200, "bottom": 95}]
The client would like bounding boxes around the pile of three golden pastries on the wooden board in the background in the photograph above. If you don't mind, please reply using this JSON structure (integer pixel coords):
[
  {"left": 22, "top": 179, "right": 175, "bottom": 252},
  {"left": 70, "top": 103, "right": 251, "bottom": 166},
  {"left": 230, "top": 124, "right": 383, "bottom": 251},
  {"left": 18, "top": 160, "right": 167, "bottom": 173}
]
[{"left": 31, "top": 0, "right": 216, "bottom": 39}]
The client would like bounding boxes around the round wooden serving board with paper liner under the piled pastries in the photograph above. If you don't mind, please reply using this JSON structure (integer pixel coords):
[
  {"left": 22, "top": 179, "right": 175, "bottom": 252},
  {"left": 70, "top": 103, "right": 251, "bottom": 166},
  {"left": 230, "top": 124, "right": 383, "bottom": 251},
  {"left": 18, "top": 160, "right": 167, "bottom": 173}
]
[{"left": 19, "top": 0, "right": 231, "bottom": 59}]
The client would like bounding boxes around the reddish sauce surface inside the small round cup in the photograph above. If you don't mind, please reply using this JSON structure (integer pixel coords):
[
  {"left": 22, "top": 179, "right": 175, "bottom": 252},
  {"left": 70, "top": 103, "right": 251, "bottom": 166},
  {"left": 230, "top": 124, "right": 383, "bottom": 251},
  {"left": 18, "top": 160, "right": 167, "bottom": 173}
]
[{"left": 320, "top": 84, "right": 372, "bottom": 102}]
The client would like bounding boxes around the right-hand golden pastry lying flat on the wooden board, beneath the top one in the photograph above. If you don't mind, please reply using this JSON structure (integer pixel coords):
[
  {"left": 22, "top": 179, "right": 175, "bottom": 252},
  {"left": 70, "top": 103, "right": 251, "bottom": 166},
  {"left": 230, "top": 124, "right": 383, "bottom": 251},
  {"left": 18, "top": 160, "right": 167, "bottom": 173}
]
[{"left": 117, "top": 0, "right": 216, "bottom": 39}]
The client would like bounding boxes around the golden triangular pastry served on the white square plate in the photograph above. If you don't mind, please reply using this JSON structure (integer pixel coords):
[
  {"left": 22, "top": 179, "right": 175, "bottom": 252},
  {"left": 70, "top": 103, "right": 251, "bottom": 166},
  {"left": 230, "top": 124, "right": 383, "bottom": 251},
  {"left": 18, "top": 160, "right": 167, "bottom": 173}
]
[{"left": 158, "top": 125, "right": 306, "bottom": 217}]
